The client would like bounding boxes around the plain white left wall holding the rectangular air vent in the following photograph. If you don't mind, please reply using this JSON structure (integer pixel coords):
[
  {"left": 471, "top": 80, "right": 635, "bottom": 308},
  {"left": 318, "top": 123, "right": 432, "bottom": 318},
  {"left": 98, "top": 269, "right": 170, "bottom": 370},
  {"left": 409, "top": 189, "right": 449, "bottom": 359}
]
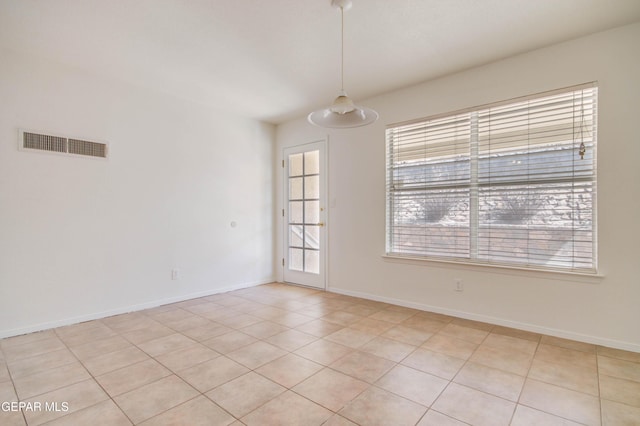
[{"left": 0, "top": 50, "right": 275, "bottom": 337}]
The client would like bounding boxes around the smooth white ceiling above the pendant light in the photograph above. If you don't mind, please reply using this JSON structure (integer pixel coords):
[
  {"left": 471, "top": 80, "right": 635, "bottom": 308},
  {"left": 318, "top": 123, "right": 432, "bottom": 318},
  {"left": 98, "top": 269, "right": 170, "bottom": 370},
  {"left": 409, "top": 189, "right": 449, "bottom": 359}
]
[{"left": 0, "top": 0, "right": 640, "bottom": 124}]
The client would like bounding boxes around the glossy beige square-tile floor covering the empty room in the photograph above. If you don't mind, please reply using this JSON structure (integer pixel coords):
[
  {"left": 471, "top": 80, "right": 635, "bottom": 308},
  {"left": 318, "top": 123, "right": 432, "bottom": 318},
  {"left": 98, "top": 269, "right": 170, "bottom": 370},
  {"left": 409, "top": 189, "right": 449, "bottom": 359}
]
[{"left": 0, "top": 284, "right": 640, "bottom": 426}]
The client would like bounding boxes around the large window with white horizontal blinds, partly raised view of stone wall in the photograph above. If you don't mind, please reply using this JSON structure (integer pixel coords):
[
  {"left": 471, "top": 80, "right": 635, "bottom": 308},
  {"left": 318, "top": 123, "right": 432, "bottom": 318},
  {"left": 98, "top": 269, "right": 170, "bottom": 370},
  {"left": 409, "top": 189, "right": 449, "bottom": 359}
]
[{"left": 386, "top": 84, "right": 597, "bottom": 272}]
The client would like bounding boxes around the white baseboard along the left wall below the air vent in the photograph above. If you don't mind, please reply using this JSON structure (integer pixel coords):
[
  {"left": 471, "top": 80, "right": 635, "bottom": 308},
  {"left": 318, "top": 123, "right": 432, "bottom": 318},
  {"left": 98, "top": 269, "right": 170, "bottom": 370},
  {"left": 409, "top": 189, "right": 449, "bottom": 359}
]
[{"left": 0, "top": 278, "right": 275, "bottom": 339}]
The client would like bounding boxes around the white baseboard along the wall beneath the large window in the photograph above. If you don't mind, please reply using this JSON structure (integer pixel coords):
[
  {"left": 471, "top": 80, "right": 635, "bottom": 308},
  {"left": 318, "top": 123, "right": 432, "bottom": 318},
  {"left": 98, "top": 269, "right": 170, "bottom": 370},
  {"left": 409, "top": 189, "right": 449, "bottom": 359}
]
[{"left": 327, "top": 287, "right": 640, "bottom": 352}]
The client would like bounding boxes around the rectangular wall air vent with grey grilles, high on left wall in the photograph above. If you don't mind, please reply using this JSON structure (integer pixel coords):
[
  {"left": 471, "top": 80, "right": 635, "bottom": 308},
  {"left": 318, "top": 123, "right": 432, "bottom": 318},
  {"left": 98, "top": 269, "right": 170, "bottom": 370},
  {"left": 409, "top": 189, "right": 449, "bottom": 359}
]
[{"left": 19, "top": 130, "right": 107, "bottom": 158}]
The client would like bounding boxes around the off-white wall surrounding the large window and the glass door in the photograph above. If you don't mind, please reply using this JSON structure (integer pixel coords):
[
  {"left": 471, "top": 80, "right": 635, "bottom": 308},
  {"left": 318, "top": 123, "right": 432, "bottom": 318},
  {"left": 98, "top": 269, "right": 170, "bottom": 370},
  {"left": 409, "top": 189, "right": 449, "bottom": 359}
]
[{"left": 276, "top": 24, "right": 640, "bottom": 352}]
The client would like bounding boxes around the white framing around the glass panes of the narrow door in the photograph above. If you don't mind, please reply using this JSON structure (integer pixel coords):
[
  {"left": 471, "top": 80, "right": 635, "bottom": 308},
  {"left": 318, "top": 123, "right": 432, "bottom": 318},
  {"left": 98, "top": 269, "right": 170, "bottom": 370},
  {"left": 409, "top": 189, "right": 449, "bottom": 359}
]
[{"left": 281, "top": 139, "right": 330, "bottom": 290}]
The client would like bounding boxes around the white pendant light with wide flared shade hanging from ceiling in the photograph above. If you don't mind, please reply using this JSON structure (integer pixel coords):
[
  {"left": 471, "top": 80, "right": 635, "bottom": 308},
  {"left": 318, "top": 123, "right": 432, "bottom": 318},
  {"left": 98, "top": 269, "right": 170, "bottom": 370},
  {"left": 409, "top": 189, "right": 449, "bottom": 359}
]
[{"left": 307, "top": 0, "right": 378, "bottom": 129}]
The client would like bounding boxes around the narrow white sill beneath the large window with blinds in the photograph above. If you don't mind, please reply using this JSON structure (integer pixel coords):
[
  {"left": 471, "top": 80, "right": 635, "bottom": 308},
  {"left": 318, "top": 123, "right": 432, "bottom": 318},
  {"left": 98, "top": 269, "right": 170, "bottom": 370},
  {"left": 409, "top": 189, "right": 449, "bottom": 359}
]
[{"left": 382, "top": 254, "right": 604, "bottom": 284}]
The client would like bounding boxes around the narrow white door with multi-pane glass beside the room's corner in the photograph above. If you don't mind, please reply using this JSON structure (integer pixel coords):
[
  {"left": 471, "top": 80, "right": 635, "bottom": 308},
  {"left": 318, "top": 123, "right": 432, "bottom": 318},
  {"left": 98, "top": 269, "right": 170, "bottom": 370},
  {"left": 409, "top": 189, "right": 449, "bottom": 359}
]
[{"left": 283, "top": 141, "right": 327, "bottom": 289}]
